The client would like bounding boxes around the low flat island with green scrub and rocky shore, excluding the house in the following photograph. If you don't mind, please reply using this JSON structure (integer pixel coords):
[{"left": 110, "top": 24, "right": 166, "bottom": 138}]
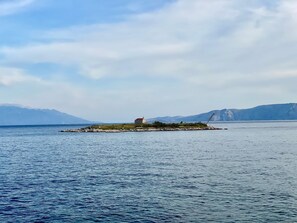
[{"left": 62, "top": 121, "right": 226, "bottom": 133}]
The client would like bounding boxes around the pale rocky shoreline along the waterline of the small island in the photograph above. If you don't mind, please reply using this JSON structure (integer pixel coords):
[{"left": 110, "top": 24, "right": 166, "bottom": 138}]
[{"left": 61, "top": 126, "right": 227, "bottom": 133}]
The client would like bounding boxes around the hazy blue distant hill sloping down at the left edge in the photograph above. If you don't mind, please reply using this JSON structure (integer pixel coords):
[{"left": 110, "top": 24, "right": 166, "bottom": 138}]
[{"left": 0, "top": 105, "right": 90, "bottom": 126}]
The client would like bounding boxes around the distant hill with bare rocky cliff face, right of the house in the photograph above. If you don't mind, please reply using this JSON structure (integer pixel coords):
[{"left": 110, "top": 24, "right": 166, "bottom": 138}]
[{"left": 148, "top": 103, "right": 297, "bottom": 123}]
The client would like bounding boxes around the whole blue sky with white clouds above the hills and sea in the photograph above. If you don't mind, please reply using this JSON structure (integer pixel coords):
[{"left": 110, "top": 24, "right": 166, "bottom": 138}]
[{"left": 0, "top": 0, "right": 297, "bottom": 122}]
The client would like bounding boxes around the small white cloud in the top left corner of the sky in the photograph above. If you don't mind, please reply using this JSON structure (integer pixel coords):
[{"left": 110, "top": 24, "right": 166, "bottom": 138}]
[{"left": 0, "top": 0, "right": 35, "bottom": 16}]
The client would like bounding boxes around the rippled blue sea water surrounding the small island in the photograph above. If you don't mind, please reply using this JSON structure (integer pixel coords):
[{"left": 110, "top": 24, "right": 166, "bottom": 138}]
[{"left": 0, "top": 122, "right": 297, "bottom": 223}]
